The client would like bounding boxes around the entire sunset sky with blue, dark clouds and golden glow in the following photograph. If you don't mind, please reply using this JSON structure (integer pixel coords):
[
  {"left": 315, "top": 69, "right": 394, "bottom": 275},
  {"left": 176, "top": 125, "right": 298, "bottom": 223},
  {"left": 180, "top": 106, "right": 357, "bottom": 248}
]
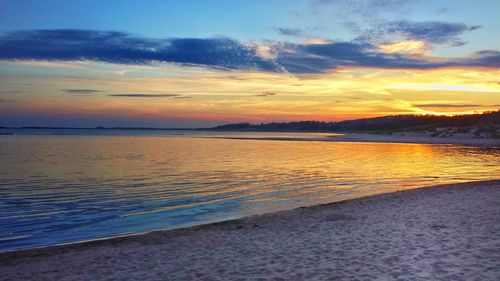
[{"left": 0, "top": 0, "right": 500, "bottom": 127}]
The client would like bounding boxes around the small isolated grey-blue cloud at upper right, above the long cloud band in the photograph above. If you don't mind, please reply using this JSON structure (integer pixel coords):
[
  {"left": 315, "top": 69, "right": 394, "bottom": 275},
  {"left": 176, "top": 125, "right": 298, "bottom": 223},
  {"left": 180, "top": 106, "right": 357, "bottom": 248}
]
[{"left": 387, "top": 21, "right": 481, "bottom": 46}]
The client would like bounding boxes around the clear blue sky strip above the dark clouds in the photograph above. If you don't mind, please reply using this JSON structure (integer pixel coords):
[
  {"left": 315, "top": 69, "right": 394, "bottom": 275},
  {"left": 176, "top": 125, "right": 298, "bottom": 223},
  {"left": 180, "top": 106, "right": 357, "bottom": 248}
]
[{"left": 0, "top": 0, "right": 500, "bottom": 53}]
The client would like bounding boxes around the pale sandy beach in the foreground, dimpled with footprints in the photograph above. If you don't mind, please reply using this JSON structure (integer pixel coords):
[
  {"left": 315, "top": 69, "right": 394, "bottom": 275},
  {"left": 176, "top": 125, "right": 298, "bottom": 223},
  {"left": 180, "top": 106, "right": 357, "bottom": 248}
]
[{"left": 0, "top": 180, "right": 500, "bottom": 280}]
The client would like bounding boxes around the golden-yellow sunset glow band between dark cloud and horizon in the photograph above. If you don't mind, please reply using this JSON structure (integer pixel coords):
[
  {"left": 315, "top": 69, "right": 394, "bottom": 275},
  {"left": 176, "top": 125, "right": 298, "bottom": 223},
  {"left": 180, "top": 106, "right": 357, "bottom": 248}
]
[{"left": 0, "top": 62, "right": 500, "bottom": 123}]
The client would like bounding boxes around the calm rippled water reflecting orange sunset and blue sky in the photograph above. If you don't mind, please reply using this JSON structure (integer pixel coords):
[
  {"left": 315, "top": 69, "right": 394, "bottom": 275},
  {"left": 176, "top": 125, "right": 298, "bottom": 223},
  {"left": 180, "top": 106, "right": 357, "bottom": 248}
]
[{"left": 0, "top": 130, "right": 500, "bottom": 251}]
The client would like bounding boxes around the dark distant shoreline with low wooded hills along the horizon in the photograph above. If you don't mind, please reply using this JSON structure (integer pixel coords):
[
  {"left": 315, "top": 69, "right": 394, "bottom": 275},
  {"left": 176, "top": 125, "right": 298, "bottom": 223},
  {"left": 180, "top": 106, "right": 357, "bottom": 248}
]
[{"left": 0, "top": 110, "right": 500, "bottom": 132}]
